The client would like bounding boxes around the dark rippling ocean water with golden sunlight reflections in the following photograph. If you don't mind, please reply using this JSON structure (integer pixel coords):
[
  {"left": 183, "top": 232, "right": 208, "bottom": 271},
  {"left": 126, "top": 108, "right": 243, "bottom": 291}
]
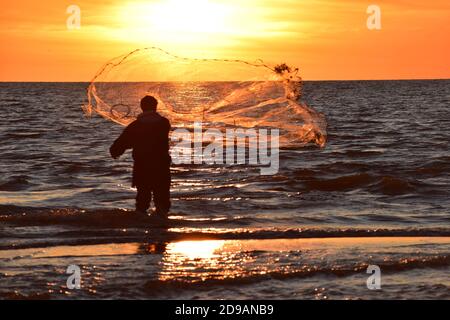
[{"left": 0, "top": 80, "right": 450, "bottom": 299}]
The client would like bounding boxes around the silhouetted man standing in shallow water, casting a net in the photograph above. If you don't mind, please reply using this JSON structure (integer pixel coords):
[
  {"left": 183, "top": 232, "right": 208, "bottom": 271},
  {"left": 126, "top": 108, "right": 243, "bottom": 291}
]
[{"left": 110, "top": 96, "right": 171, "bottom": 219}]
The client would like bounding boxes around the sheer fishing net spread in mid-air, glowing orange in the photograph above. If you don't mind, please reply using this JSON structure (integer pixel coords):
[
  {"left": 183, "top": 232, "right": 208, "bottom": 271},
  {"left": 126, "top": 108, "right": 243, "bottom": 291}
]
[{"left": 83, "top": 47, "right": 326, "bottom": 147}]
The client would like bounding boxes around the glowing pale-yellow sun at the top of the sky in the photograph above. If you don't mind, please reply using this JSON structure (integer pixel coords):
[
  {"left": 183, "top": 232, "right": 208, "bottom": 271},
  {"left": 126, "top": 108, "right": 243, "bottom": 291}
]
[{"left": 119, "top": 0, "right": 233, "bottom": 45}]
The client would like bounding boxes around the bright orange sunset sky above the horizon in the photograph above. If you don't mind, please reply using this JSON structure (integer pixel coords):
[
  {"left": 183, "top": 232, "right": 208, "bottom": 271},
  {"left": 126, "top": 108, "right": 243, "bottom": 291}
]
[{"left": 0, "top": 0, "right": 450, "bottom": 81}]
